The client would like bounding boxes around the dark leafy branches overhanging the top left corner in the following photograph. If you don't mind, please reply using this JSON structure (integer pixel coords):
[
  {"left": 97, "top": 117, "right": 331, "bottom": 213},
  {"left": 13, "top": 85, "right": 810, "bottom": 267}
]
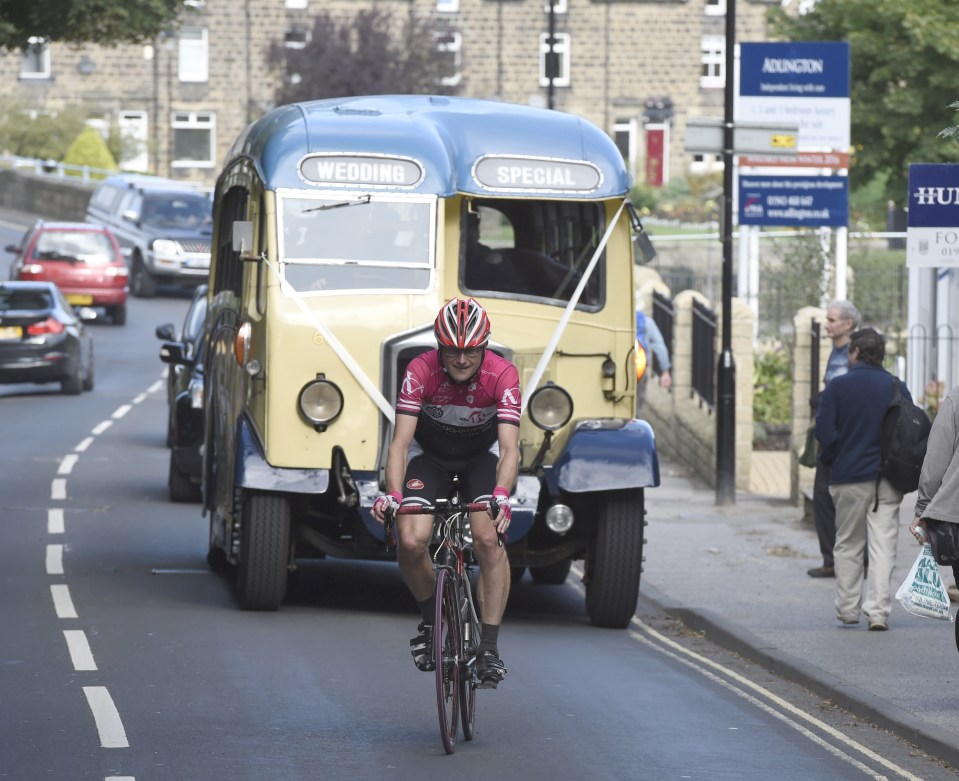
[{"left": 0, "top": 0, "right": 183, "bottom": 51}]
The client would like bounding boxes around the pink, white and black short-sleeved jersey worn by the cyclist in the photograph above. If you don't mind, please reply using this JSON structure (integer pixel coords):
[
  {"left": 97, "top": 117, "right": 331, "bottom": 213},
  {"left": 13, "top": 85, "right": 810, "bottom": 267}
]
[{"left": 396, "top": 350, "right": 520, "bottom": 460}]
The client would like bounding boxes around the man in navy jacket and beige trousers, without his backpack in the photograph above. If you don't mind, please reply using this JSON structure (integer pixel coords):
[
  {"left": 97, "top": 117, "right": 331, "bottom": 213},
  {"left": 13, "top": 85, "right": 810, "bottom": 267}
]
[{"left": 816, "top": 328, "right": 912, "bottom": 631}]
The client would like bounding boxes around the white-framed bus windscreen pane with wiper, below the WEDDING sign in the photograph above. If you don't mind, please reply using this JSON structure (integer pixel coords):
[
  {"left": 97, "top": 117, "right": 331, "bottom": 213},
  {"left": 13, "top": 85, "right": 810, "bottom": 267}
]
[{"left": 278, "top": 193, "right": 435, "bottom": 292}]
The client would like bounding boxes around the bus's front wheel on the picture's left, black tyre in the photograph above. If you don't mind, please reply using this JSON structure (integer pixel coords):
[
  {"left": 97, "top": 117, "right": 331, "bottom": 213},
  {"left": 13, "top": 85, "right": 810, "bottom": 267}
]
[{"left": 236, "top": 492, "right": 290, "bottom": 610}]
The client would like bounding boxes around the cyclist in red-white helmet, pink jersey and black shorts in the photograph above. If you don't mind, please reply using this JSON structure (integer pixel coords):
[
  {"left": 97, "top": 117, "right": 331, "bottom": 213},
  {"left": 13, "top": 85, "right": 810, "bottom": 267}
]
[{"left": 373, "top": 298, "right": 520, "bottom": 688}]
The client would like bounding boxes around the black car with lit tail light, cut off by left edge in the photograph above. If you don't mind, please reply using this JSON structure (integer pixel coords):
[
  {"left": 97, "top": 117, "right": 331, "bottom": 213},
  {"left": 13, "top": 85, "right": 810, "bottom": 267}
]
[{"left": 0, "top": 281, "right": 96, "bottom": 395}]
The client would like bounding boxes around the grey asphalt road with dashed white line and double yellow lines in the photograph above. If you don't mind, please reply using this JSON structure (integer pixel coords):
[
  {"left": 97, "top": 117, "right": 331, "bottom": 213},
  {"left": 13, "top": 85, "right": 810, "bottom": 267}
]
[{"left": 0, "top": 207, "right": 955, "bottom": 781}]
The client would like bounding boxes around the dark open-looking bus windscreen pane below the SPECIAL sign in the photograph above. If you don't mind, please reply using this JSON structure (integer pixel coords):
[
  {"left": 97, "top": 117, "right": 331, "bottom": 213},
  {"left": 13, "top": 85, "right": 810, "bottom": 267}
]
[{"left": 460, "top": 198, "right": 606, "bottom": 311}]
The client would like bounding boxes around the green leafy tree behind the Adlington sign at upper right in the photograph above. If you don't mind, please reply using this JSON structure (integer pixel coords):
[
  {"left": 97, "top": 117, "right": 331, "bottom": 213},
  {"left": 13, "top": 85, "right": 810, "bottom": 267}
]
[{"left": 770, "top": 0, "right": 959, "bottom": 203}]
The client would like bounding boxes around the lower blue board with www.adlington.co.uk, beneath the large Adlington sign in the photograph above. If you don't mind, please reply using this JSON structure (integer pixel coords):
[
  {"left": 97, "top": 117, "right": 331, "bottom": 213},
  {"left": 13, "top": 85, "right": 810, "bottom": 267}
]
[{"left": 739, "top": 174, "right": 849, "bottom": 228}]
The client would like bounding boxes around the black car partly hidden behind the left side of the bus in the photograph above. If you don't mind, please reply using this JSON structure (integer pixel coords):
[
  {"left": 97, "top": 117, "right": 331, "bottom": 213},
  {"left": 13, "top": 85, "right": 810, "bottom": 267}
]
[{"left": 156, "top": 285, "right": 207, "bottom": 502}]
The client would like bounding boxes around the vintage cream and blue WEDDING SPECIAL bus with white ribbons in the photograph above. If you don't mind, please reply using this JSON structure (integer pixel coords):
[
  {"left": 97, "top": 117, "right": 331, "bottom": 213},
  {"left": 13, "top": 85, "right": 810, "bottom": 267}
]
[{"left": 203, "top": 96, "right": 659, "bottom": 627}]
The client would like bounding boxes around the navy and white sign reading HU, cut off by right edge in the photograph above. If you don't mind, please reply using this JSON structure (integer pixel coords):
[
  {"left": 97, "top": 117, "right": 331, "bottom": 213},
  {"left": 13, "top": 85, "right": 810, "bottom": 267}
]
[{"left": 906, "top": 163, "right": 959, "bottom": 268}]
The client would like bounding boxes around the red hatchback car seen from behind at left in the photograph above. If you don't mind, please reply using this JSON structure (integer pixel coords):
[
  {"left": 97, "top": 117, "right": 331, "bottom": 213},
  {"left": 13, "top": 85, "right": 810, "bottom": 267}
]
[{"left": 6, "top": 220, "right": 129, "bottom": 325}]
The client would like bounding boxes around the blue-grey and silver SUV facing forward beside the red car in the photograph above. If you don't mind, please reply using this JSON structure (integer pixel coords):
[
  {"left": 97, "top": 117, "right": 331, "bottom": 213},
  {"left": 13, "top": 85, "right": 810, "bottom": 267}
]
[{"left": 86, "top": 174, "right": 213, "bottom": 298}]
